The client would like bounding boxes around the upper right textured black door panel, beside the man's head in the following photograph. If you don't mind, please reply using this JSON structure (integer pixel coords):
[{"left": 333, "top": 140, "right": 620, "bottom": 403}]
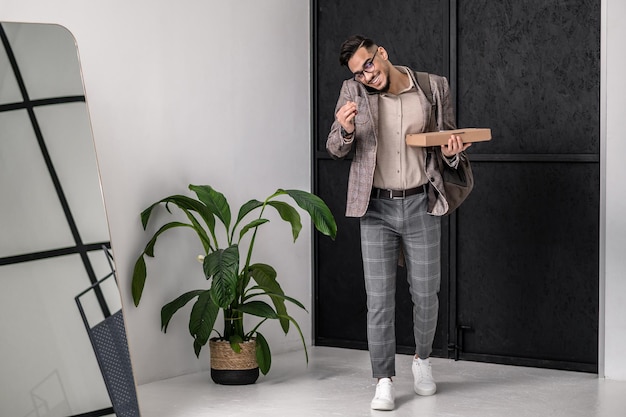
[{"left": 457, "top": 0, "right": 600, "bottom": 154}]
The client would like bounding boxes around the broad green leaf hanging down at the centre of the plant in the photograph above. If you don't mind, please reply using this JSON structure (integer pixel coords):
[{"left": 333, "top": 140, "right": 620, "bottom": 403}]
[{"left": 203, "top": 245, "right": 239, "bottom": 308}]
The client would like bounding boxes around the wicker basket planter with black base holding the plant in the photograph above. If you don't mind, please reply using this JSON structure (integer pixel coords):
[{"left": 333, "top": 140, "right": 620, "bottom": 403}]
[{"left": 209, "top": 339, "right": 259, "bottom": 385}]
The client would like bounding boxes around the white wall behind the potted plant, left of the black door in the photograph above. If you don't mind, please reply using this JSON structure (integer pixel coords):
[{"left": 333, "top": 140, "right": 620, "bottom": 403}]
[{"left": 0, "top": 0, "right": 312, "bottom": 383}]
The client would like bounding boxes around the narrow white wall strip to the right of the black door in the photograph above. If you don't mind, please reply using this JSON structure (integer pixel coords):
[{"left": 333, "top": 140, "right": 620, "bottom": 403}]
[{"left": 600, "top": 0, "right": 626, "bottom": 380}]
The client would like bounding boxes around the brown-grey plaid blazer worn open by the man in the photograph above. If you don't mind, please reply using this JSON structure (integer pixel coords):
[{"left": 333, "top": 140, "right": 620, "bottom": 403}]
[{"left": 326, "top": 68, "right": 456, "bottom": 217}]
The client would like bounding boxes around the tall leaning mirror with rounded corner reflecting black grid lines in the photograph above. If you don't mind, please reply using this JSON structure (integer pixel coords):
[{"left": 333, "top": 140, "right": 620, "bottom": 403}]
[{"left": 0, "top": 22, "right": 139, "bottom": 417}]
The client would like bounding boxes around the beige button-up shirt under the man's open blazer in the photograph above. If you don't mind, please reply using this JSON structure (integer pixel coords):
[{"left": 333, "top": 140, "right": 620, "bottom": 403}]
[{"left": 373, "top": 67, "right": 428, "bottom": 190}]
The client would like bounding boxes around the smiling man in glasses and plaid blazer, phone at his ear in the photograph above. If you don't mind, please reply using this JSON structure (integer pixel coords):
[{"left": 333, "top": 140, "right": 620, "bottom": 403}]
[{"left": 326, "top": 35, "right": 470, "bottom": 410}]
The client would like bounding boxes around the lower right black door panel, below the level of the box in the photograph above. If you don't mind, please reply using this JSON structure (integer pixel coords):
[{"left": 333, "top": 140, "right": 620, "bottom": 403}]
[{"left": 456, "top": 162, "right": 600, "bottom": 371}]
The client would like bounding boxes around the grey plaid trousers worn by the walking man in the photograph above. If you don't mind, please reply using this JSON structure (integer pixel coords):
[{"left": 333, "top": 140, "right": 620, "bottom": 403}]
[{"left": 360, "top": 193, "right": 441, "bottom": 378}]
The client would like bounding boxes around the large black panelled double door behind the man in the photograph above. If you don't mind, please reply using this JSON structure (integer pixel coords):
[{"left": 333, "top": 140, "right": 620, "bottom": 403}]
[{"left": 312, "top": 0, "right": 600, "bottom": 372}]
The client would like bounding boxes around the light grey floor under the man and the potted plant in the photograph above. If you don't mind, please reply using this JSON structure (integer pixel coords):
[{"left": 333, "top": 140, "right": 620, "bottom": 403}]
[{"left": 138, "top": 347, "right": 626, "bottom": 417}]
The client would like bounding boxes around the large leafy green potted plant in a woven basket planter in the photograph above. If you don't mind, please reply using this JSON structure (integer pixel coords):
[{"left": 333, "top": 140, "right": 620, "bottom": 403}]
[{"left": 132, "top": 185, "right": 337, "bottom": 384}]
